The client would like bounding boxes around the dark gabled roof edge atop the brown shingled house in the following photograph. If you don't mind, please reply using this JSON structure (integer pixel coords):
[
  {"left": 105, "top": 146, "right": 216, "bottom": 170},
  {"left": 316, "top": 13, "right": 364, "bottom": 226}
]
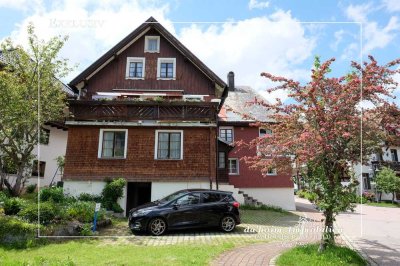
[{"left": 69, "top": 17, "right": 227, "bottom": 91}]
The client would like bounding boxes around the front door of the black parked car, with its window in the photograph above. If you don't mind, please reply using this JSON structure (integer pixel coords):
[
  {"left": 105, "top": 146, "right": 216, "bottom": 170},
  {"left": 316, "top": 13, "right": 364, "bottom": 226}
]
[{"left": 168, "top": 193, "right": 201, "bottom": 228}]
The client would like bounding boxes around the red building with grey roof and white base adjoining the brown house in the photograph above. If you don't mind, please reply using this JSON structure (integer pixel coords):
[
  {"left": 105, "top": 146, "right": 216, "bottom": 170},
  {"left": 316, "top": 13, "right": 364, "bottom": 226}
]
[{"left": 218, "top": 84, "right": 295, "bottom": 210}]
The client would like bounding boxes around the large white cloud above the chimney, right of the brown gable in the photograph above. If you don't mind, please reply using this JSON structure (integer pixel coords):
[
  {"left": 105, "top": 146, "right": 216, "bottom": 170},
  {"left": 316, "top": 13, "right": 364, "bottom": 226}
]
[{"left": 179, "top": 11, "right": 315, "bottom": 100}]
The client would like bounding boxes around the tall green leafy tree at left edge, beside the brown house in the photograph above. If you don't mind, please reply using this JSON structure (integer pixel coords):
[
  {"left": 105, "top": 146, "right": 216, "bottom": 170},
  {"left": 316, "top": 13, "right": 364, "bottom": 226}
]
[{"left": 0, "top": 24, "right": 71, "bottom": 195}]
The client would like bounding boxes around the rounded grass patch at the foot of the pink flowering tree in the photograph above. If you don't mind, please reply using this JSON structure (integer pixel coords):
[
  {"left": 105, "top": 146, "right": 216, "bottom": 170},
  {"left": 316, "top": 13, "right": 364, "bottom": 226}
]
[{"left": 276, "top": 244, "right": 367, "bottom": 266}]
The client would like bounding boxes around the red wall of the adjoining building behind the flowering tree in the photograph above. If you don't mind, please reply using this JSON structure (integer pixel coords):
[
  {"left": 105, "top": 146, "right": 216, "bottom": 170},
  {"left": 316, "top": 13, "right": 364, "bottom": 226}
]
[{"left": 228, "top": 126, "right": 293, "bottom": 188}]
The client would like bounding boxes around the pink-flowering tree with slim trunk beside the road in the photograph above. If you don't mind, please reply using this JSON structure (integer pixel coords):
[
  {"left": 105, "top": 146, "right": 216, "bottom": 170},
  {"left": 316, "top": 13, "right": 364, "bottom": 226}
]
[{"left": 246, "top": 57, "right": 400, "bottom": 250}]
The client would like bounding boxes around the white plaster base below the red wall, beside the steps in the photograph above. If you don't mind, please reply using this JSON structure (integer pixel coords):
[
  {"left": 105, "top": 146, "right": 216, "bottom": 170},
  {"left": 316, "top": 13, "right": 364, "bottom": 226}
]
[{"left": 240, "top": 188, "right": 296, "bottom": 211}]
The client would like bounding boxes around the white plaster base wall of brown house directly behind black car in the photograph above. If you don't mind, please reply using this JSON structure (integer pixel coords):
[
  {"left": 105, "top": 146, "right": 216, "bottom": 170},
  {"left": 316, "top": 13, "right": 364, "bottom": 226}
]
[{"left": 151, "top": 182, "right": 210, "bottom": 201}]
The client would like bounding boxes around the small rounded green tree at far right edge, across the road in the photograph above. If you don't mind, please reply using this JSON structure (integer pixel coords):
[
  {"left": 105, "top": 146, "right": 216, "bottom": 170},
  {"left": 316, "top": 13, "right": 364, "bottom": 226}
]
[{"left": 376, "top": 167, "right": 400, "bottom": 203}]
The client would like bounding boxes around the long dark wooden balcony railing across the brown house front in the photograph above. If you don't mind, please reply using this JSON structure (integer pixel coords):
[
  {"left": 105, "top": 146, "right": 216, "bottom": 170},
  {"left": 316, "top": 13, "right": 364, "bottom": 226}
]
[{"left": 68, "top": 100, "right": 218, "bottom": 122}]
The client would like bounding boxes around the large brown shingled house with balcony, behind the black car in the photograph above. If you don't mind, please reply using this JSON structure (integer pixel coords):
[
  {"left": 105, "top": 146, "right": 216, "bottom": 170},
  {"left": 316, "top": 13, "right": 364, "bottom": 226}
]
[{"left": 62, "top": 18, "right": 234, "bottom": 215}]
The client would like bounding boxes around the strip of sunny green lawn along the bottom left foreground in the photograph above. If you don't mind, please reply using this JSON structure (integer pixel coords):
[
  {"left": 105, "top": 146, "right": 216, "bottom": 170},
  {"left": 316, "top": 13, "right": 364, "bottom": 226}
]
[{"left": 0, "top": 240, "right": 235, "bottom": 265}]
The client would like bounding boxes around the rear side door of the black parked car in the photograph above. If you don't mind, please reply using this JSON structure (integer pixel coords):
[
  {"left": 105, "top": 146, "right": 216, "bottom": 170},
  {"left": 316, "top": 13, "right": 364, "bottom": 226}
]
[{"left": 199, "top": 192, "right": 227, "bottom": 226}]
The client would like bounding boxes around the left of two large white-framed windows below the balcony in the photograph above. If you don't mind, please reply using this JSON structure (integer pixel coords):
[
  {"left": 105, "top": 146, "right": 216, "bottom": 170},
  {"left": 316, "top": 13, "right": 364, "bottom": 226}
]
[{"left": 98, "top": 129, "right": 128, "bottom": 159}]
